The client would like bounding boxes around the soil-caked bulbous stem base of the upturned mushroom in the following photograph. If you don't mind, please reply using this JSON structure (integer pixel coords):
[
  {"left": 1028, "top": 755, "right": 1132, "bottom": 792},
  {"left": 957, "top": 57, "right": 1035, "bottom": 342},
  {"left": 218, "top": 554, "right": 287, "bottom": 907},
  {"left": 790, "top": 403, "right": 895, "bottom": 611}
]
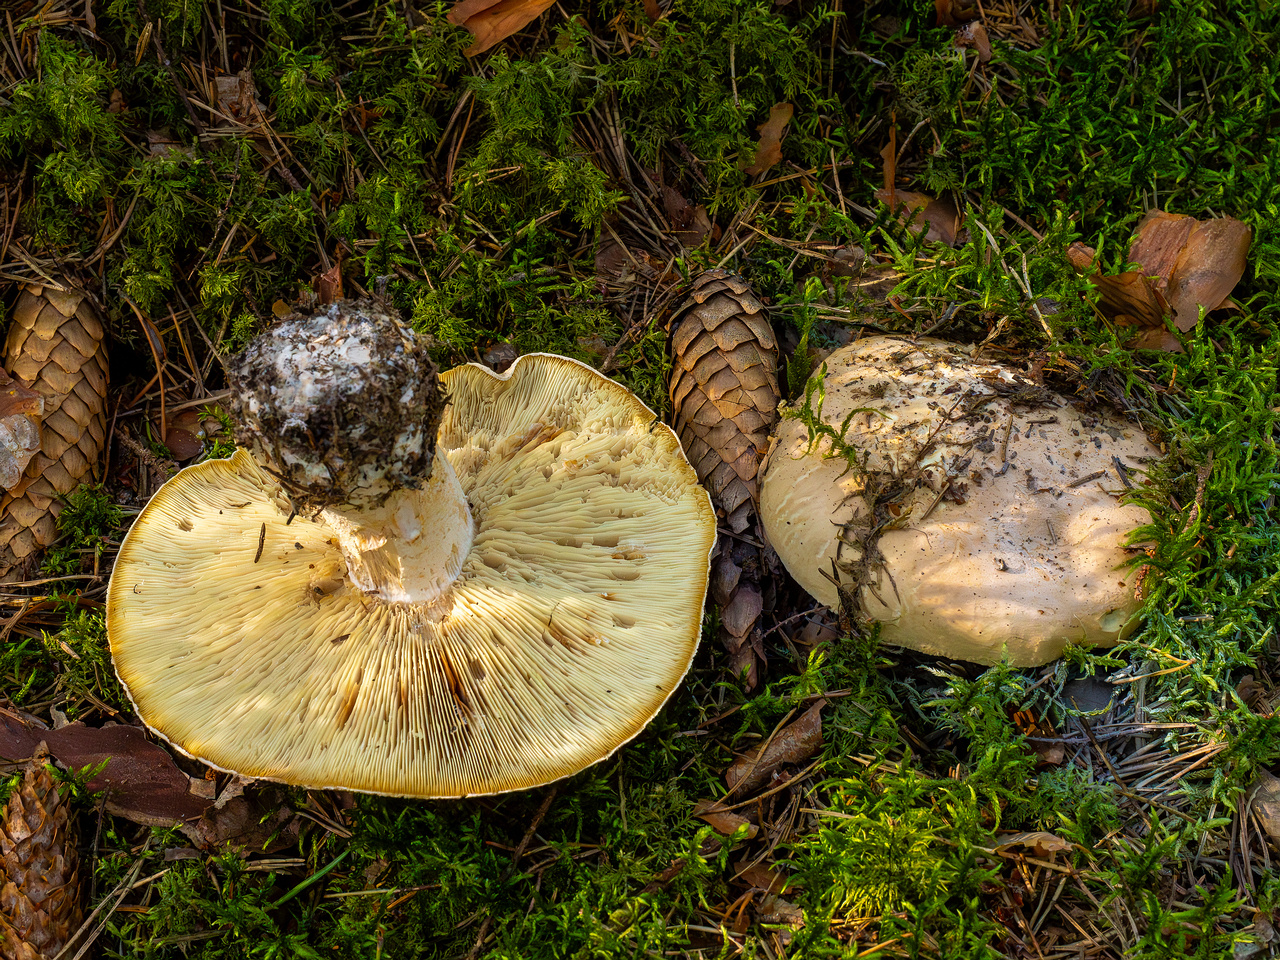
[{"left": 230, "top": 301, "right": 444, "bottom": 509}]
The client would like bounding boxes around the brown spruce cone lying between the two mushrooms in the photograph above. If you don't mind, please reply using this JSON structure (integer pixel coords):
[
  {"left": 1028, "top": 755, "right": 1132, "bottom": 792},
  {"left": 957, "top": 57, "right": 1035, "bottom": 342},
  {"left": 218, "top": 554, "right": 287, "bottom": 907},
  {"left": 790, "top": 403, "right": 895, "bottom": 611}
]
[{"left": 671, "top": 269, "right": 781, "bottom": 534}]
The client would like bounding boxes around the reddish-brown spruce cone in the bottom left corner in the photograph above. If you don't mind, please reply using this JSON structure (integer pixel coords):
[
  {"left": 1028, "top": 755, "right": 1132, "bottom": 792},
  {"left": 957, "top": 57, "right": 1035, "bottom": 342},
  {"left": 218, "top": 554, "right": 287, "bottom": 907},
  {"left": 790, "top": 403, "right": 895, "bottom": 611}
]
[{"left": 0, "top": 755, "right": 83, "bottom": 960}]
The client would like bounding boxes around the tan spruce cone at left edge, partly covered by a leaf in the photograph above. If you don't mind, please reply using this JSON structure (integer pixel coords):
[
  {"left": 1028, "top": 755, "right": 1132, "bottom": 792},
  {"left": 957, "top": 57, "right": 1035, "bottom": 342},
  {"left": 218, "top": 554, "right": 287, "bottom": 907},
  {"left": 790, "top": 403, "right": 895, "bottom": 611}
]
[{"left": 0, "top": 287, "right": 108, "bottom": 581}]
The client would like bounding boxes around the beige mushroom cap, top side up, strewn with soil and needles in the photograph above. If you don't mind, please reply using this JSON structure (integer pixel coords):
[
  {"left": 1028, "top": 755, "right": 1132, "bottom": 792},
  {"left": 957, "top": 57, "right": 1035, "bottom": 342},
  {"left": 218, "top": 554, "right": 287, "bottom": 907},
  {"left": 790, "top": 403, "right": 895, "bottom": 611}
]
[{"left": 760, "top": 337, "right": 1160, "bottom": 666}]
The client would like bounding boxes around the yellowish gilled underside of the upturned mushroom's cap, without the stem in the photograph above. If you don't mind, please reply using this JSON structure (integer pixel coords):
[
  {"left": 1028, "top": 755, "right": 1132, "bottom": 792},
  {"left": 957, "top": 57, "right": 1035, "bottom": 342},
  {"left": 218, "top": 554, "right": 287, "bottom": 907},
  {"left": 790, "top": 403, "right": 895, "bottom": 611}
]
[{"left": 108, "top": 355, "right": 716, "bottom": 797}]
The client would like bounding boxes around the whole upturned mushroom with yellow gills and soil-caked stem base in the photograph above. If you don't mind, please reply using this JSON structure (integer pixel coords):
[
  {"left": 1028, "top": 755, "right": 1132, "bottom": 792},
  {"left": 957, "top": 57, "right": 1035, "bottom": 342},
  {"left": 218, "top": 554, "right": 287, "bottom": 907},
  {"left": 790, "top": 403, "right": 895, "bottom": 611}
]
[{"left": 108, "top": 301, "right": 716, "bottom": 797}]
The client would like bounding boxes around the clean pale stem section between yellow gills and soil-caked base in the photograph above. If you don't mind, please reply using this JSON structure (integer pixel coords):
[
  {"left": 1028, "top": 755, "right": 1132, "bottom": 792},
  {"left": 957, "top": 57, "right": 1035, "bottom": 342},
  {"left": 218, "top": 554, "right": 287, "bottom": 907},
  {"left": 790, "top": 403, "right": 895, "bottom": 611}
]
[{"left": 320, "top": 453, "right": 475, "bottom": 603}]
